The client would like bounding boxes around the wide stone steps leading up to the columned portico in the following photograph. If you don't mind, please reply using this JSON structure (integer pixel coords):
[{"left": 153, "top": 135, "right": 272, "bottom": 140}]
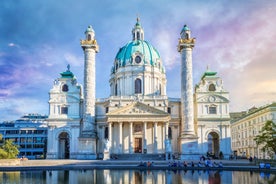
[{"left": 110, "top": 153, "right": 166, "bottom": 161}]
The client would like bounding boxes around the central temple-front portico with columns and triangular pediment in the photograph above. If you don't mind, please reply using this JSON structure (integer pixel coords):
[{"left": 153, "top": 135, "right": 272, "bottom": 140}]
[{"left": 107, "top": 102, "right": 170, "bottom": 154}]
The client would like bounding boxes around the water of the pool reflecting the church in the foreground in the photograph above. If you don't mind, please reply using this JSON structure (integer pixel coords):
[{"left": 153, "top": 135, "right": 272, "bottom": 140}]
[{"left": 0, "top": 170, "right": 276, "bottom": 184}]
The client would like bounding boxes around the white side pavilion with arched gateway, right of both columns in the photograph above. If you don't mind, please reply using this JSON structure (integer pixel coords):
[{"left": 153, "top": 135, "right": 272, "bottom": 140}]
[{"left": 195, "top": 69, "right": 231, "bottom": 158}]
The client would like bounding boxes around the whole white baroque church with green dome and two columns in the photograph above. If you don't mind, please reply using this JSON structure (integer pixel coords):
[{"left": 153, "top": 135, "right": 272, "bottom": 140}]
[{"left": 47, "top": 19, "right": 231, "bottom": 160}]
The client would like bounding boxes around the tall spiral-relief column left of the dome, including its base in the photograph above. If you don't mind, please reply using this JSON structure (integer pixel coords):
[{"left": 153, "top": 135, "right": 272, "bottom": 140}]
[{"left": 79, "top": 26, "right": 99, "bottom": 159}]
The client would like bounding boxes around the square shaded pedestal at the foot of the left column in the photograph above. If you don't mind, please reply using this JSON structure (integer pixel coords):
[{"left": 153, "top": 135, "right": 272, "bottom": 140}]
[{"left": 76, "top": 137, "right": 97, "bottom": 160}]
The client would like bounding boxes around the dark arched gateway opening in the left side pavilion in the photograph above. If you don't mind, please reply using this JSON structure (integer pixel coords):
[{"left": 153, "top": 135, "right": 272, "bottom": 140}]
[{"left": 58, "top": 132, "right": 70, "bottom": 159}]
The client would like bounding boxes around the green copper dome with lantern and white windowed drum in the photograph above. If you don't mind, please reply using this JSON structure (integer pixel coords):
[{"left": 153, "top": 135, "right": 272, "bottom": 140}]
[{"left": 109, "top": 18, "right": 167, "bottom": 96}]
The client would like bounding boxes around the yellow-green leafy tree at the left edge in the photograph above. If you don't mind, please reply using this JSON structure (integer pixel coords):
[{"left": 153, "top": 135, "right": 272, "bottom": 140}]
[{"left": 0, "top": 134, "right": 19, "bottom": 159}]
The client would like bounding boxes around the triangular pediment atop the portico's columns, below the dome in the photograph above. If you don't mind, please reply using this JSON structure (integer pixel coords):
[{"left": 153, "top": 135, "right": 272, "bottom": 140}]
[{"left": 106, "top": 102, "right": 170, "bottom": 121}]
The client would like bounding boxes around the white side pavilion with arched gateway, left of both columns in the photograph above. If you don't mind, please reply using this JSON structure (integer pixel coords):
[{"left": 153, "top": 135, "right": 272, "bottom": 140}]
[{"left": 47, "top": 67, "right": 83, "bottom": 159}]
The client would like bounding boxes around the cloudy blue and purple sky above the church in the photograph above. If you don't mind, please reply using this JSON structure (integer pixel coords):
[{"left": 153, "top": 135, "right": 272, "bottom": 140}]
[{"left": 0, "top": 0, "right": 276, "bottom": 121}]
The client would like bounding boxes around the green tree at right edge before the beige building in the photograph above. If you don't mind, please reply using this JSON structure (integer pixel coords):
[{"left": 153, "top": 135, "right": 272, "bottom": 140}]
[{"left": 254, "top": 120, "right": 276, "bottom": 158}]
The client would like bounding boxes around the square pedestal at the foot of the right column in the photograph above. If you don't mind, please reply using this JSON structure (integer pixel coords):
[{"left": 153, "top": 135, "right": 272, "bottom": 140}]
[{"left": 179, "top": 134, "right": 200, "bottom": 160}]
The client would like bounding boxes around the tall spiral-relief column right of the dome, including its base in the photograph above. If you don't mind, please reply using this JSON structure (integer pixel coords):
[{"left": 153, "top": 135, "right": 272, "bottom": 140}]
[{"left": 178, "top": 25, "right": 198, "bottom": 159}]
